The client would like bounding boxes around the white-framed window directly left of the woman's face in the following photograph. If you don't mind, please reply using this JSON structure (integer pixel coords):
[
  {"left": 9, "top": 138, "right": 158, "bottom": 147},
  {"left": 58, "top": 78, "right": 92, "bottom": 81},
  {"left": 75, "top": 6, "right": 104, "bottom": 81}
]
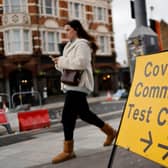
[{"left": 42, "top": 31, "right": 60, "bottom": 54}]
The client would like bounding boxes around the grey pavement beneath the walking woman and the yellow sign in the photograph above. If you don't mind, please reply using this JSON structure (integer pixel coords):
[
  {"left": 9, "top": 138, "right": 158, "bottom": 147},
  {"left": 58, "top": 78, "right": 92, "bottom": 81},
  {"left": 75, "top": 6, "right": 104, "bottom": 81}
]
[{"left": 0, "top": 97, "right": 165, "bottom": 168}]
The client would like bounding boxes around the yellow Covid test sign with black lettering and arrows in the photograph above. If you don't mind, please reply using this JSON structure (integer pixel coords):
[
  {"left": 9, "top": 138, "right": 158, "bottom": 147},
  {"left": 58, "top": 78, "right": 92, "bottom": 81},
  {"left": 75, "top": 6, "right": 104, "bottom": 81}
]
[{"left": 116, "top": 52, "right": 168, "bottom": 167}]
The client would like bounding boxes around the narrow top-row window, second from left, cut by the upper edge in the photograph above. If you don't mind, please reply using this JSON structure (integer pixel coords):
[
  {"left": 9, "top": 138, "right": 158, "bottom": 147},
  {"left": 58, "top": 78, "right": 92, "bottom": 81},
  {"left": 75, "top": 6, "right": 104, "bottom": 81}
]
[{"left": 40, "top": 0, "right": 58, "bottom": 16}]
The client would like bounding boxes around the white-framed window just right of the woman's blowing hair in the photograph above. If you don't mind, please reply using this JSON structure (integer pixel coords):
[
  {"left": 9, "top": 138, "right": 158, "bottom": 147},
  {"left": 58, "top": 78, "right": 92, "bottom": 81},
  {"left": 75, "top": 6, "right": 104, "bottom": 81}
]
[{"left": 98, "top": 36, "right": 110, "bottom": 54}]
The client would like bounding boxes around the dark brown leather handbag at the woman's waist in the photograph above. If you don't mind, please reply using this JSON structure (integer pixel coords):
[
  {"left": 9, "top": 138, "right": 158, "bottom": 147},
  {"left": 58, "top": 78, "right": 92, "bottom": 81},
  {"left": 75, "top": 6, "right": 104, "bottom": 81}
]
[{"left": 61, "top": 69, "right": 83, "bottom": 86}]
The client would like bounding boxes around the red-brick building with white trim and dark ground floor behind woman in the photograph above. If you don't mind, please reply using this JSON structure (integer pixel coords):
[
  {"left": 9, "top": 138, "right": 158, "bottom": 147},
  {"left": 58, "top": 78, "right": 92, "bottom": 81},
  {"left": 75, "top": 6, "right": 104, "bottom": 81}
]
[{"left": 0, "top": 0, "right": 117, "bottom": 106}]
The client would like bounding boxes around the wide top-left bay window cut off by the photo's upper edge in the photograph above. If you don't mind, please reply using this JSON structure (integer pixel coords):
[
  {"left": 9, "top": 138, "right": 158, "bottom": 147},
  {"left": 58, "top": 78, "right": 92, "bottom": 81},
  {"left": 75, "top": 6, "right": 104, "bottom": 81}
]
[{"left": 4, "top": 0, "right": 27, "bottom": 13}]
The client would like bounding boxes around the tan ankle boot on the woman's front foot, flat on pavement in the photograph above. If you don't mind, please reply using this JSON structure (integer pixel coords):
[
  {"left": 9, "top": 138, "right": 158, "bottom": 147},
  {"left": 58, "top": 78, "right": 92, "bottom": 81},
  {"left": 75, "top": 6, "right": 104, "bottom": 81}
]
[{"left": 52, "top": 141, "right": 76, "bottom": 164}]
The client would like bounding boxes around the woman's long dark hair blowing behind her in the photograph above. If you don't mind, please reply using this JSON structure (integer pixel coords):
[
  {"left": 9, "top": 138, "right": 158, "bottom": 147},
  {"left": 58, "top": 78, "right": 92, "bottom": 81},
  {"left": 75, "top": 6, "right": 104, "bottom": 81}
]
[{"left": 66, "top": 20, "right": 98, "bottom": 55}]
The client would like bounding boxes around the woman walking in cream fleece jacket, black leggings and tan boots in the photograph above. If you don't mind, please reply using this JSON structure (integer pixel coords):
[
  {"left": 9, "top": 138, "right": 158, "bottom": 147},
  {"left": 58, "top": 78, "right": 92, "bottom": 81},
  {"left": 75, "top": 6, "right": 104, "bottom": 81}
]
[{"left": 52, "top": 20, "right": 116, "bottom": 163}]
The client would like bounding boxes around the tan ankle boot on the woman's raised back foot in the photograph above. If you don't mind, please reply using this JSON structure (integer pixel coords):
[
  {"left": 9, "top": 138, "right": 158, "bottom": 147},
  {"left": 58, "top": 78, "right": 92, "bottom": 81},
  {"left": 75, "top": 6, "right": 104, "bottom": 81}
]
[{"left": 101, "top": 123, "right": 117, "bottom": 146}]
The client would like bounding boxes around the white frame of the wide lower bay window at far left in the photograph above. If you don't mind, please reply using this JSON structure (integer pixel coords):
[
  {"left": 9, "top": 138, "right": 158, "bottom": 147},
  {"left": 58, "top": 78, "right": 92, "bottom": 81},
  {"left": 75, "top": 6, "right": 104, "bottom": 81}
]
[{"left": 3, "top": 27, "right": 33, "bottom": 56}]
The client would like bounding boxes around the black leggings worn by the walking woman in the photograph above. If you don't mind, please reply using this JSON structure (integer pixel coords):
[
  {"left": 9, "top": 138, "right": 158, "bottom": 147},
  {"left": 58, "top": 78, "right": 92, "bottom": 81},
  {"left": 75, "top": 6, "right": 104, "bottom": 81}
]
[{"left": 62, "top": 91, "right": 104, "bottom": 140}]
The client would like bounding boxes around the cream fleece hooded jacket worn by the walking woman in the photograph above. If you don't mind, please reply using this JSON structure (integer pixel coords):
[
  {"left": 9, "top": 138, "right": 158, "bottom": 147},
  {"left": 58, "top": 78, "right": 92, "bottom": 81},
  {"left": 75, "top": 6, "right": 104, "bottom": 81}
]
[{"left": 55, "top": 38, "right": 94, "bottom": 93}]
